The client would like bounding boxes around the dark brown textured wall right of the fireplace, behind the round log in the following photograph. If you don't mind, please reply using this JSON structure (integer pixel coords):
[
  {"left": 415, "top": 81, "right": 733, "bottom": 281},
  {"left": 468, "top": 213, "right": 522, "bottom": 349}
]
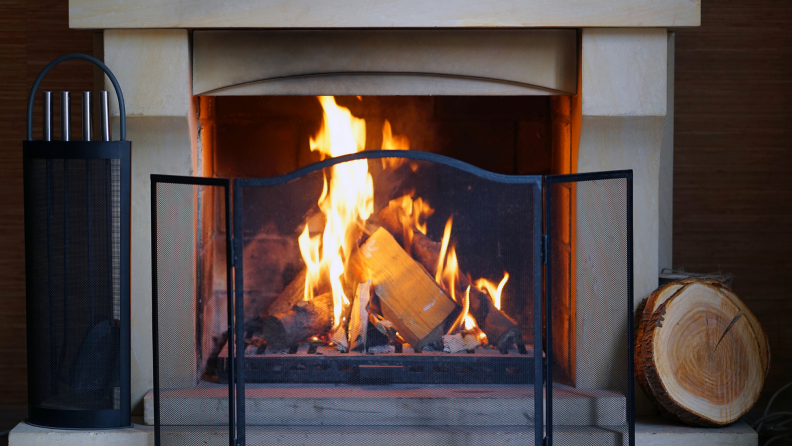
[{"left": 674, "top": 0, "right": 792, "bottom": 420}]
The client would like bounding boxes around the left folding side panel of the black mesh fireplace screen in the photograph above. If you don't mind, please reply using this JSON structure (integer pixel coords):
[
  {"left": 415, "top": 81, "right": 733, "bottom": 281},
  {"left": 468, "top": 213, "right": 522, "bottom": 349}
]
[{"left": 152, "top": 178, "right": 233, "bottom": 445}]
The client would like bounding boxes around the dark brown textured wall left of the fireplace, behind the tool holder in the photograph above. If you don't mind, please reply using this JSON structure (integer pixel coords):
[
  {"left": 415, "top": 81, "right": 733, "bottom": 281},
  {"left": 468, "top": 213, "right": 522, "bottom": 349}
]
[{"left": 0, "top": 0, "right": 93, "bottom": 416}]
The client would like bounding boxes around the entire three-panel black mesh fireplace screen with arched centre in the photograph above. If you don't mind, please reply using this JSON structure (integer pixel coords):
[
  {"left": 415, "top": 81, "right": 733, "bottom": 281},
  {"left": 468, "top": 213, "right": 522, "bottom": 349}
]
[{"left": 152, "top": 154, "right": 632, "bottom": 445}]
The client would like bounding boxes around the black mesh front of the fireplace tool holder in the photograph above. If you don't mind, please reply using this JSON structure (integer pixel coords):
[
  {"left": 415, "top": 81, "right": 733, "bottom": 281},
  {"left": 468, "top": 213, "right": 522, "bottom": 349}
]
[{"left": 25, "top": 159, "right": 121, "bottom": 410}]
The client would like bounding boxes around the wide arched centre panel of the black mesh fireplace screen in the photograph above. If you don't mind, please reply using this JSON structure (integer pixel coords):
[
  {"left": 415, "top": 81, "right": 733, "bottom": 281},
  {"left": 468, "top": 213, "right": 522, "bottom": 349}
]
[{"left": 234, "top": 151, "right": 543, "bottom": 445}]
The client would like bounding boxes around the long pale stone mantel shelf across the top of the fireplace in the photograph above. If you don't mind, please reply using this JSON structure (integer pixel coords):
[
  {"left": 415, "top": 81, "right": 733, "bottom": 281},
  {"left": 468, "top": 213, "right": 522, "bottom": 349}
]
[{"left": 69, "top": 0, "right": 701, "bottom": 29}]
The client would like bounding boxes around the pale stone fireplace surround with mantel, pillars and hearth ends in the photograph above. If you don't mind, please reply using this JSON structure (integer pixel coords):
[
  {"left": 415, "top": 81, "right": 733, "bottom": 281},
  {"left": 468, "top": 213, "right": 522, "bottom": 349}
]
[{"left": 6, "top": 0, "right": 756, "bottom": 446}]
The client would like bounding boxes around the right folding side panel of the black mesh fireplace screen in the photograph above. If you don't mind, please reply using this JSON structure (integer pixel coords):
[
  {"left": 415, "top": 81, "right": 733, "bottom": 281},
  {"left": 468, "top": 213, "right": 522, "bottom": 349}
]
[{"left": 545, "top": 173, "right": 634, "bottom": 446}]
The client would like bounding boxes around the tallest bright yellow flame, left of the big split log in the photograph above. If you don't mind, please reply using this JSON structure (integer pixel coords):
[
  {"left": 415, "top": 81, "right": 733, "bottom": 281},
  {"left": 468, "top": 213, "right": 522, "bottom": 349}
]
[{"left": 299, "top": 96, "right": 374, "bottom": 328}]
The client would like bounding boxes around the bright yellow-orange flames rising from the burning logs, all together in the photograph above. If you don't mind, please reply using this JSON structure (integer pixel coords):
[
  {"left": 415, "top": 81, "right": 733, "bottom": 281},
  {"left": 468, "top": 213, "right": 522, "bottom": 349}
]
[{"left": 298, "top": 96, "right": 509, "bottom": 348}]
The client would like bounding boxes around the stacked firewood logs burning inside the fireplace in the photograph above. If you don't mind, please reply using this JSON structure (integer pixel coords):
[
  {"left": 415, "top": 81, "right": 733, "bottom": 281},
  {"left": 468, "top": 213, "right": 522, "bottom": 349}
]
[{"left": 262, "top": 203, "right": 520, "bottom": 351}]
